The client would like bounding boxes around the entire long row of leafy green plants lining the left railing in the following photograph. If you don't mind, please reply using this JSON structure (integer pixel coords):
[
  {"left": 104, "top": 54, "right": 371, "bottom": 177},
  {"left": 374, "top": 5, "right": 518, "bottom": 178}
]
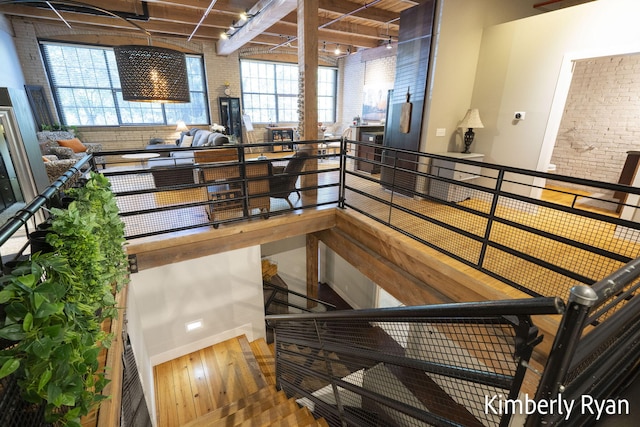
[{"left": 0, "top": 173, "right": 127, "bottom": 426}]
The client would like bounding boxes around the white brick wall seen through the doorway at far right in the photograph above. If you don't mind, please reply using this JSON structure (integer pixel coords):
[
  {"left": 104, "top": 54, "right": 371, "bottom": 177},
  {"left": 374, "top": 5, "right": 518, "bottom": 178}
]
[{"left": 551, "top": 54, "right": 640, "bottom": 187}]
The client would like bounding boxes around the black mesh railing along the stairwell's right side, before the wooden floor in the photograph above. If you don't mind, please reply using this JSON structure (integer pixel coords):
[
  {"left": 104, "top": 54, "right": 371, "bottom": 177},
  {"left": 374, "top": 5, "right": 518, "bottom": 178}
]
[{"left": 342, "top": 141, "right": 640, "bottom": 298}]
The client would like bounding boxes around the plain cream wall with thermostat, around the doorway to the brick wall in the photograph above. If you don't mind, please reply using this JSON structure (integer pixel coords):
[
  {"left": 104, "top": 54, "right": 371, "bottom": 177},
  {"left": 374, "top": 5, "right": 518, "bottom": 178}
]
[{"left": 472, "top": 0, "right": 640, "bottom": 170}]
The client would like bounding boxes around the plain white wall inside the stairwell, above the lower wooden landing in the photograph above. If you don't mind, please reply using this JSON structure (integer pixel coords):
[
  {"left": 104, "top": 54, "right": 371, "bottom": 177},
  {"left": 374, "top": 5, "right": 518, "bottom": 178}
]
[{"left": 129, "top": 246, "right": 264, "bottom": 365}]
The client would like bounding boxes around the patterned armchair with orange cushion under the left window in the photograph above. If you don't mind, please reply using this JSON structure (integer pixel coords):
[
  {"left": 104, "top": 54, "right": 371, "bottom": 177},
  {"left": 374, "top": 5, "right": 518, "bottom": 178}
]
[{"left": 36, "top": 131, "right": 105, "bottom": 182}]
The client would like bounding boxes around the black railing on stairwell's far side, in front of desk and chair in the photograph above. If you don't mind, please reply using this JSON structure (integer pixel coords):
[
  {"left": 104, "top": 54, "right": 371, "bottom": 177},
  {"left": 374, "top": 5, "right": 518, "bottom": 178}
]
[{"left": 94, "top": 141, "right": 340, "bottom": 239}]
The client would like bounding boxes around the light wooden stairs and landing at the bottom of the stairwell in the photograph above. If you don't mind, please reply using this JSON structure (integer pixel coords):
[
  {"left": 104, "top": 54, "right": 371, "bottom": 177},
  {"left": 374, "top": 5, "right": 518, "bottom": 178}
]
[{"left": 154, "top": 335, "right": 328, "bottom": 427}]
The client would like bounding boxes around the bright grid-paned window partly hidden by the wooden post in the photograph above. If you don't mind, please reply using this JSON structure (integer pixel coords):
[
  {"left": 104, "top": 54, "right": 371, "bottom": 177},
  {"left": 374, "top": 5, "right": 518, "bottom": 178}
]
[{"left": 240, "top": 60, "right": 338, "bottom": 123}]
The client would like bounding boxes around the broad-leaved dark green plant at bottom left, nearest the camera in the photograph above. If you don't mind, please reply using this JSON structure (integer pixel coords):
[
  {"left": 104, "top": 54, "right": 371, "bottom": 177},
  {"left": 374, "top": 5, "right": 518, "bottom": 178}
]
[{"left": 0, "top": 253, "right": 110, "bottom": 426}]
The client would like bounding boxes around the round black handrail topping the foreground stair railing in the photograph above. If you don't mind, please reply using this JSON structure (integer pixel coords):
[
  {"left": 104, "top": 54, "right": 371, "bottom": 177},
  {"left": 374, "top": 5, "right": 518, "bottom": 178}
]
[{"left": 266, "top": 297, "right": 564, "bottom": 322}]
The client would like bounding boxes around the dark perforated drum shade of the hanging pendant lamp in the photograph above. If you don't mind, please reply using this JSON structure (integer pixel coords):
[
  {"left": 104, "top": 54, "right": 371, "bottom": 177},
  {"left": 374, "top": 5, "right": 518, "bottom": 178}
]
[{"left": 113, "top": 45, "right": 191, "bottom": 102}]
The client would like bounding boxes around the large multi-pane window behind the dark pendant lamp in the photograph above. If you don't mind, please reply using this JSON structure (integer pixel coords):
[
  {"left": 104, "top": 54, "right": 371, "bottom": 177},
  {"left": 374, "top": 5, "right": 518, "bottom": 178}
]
[{"left": 42, "top": 42, "right": 209, "bottom": 126}]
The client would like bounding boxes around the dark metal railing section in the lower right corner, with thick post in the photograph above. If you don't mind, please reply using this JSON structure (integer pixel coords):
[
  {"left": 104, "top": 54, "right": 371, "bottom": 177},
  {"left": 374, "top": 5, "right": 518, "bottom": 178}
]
[{"left": 527, "top": 259, "right": 640, "bottom": 427}]
